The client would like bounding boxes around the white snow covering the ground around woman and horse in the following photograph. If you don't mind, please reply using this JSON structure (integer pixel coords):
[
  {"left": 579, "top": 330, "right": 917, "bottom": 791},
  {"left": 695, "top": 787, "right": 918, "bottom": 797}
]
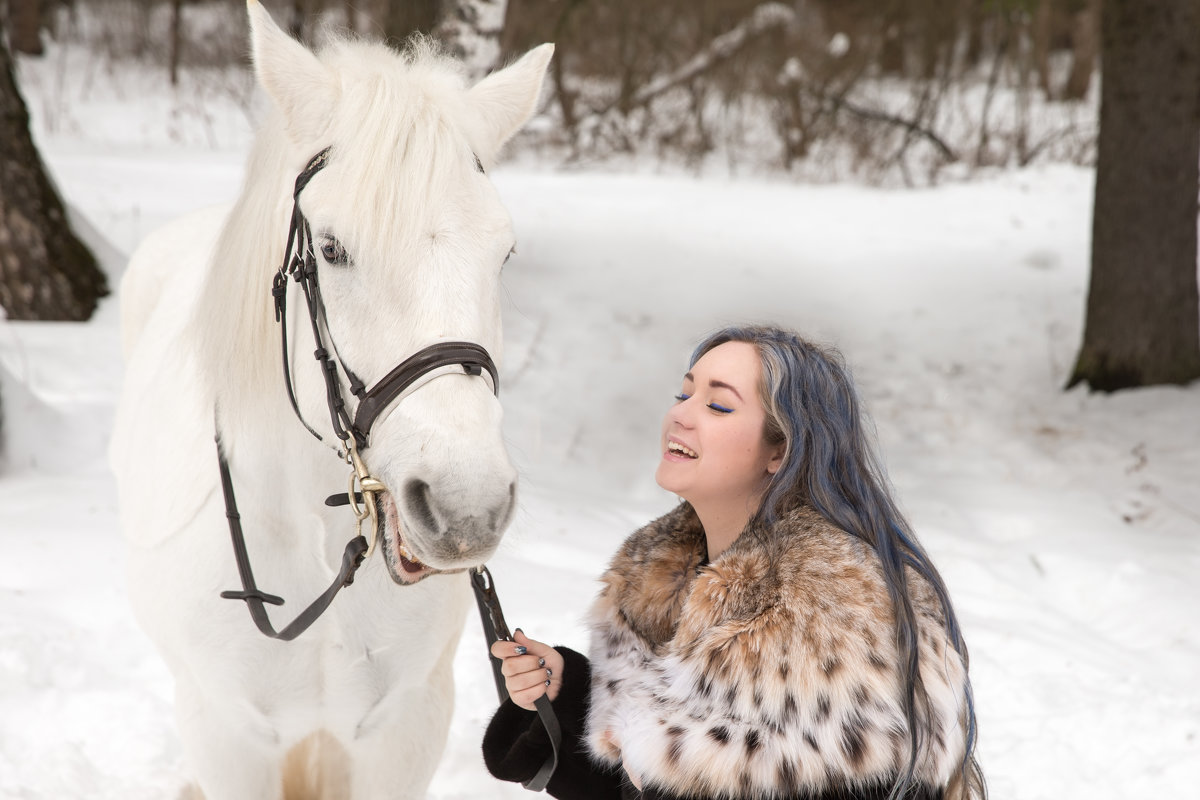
[{"left": 0, "top": 47, "right": 1200, "bottom": 800}]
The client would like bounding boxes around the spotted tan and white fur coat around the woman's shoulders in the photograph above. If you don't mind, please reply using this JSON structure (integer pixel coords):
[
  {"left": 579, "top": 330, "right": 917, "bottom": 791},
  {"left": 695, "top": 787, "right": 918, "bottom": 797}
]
[{"left": 584, "top": 503, "right": 966, "bottom": 798}]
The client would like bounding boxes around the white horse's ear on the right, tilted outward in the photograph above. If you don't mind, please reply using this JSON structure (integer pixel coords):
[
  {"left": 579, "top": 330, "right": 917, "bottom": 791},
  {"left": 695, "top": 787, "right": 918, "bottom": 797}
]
[{"left": 469, "top": 44, "right": 554, "bottom": 166}]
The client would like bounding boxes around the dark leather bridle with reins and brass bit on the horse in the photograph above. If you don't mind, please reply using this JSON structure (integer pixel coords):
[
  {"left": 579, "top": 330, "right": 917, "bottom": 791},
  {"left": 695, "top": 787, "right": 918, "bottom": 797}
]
[{"left": 216, "top": 148, "right": 562, "bottom": 792}]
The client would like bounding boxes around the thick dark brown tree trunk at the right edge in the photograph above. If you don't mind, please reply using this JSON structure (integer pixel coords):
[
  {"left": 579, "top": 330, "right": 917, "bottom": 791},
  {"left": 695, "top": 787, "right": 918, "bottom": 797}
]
[{"left": 1068, "top": 0, "right": 1200, "bottom": 391}]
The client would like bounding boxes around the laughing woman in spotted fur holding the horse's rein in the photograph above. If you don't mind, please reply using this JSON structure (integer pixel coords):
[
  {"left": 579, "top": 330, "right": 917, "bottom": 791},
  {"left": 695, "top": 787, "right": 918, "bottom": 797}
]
[{"left": 484, "top": 327, "right": 986, "bottom": 800}]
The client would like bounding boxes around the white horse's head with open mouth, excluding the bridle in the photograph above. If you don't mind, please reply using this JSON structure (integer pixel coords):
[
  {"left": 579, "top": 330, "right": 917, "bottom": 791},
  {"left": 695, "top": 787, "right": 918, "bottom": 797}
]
[{"left": 248, "top": 0, "right": 553, "bottom": 583}]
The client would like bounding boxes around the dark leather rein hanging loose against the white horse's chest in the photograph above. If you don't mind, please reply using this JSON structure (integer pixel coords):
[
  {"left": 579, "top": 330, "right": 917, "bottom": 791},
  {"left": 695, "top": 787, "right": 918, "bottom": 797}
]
[{"left": 217, "top": 437, "right": 367, "bottom": 642}]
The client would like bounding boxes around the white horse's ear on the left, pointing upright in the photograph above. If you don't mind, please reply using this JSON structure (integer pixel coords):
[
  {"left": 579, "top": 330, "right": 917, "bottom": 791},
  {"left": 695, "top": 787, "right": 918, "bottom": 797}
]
[{"left": 246, "top": 0, "right": 337, "bottom": 146}]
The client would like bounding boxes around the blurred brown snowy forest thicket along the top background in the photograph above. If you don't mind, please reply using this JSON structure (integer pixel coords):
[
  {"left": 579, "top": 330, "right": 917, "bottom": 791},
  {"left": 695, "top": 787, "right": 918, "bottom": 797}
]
[{"left": 11, "top": 0, "right": 1100, "bottom": 184}]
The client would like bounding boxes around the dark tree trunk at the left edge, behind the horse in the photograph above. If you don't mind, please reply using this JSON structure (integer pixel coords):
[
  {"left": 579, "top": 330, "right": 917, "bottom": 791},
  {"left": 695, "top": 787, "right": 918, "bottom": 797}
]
[{"left": 0, "top": 18, "right": 108, "bottom": 320}]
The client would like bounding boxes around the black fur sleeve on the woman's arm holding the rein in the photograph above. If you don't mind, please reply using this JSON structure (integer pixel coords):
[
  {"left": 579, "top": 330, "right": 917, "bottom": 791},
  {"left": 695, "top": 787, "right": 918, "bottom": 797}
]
[{"left": 484, "top": 648, "right": 623, "bottom": 800}]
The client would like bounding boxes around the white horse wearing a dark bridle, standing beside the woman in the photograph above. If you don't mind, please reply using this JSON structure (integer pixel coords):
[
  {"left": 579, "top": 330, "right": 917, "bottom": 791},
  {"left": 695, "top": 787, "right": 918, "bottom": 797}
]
[{"left": 110, "top": 0, "right": 553, "bottom": 800}]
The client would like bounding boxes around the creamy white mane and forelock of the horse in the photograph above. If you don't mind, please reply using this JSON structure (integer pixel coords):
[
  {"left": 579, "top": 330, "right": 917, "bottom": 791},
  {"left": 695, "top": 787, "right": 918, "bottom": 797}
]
[{"left": 196, "top": 36, "right": 474, "bottom": 431}]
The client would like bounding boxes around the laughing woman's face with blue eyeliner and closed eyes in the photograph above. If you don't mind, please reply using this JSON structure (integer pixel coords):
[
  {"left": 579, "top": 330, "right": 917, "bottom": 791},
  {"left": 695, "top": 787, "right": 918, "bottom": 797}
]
[{"left": 654, "top": 342, "right": 784, "bottom": 509}]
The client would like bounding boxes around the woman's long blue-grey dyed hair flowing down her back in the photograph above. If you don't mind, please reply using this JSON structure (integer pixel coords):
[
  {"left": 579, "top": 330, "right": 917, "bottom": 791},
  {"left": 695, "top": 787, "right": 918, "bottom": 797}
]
[{"left": 691, "top": 325, "right": 986, "bottom": 800}]
